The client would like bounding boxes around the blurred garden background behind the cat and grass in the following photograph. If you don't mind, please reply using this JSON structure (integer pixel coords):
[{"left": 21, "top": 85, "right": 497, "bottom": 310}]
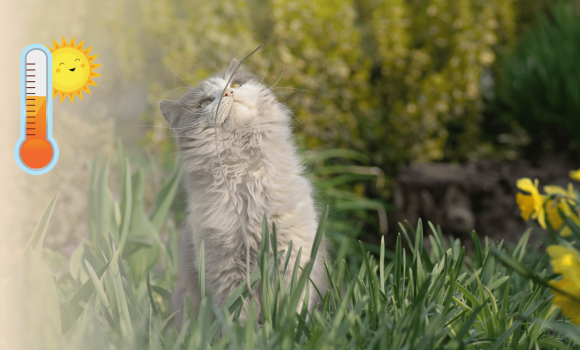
[{"left": 0, "top": 0, "right": 580, "bottom": 348}]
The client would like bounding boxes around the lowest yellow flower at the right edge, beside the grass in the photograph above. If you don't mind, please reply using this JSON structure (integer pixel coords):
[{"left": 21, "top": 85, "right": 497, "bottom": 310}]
[{"left": 546, "top": 245, "right": 580, "bottom": 325}]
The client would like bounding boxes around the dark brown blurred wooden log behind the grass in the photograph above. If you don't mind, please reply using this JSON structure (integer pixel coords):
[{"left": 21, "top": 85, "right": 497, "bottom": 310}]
[{"left": 394, "top": 157, "right": 580, "bottom": 241}]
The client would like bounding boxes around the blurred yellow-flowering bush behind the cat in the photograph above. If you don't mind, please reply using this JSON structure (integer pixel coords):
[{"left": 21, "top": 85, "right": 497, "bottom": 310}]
[{"left": 111, "top": 0, "right": 516, "bottom": 171}]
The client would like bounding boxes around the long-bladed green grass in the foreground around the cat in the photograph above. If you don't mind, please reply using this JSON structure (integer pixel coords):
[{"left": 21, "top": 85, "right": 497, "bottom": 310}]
[{"left": 4, "top": 149, "right": 580, "bottom": 350}]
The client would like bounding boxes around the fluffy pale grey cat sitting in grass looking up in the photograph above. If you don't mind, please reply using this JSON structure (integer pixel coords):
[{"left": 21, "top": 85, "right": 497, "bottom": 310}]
[{"left": 159, "top": 59, "right": 328, "bottom": 320}]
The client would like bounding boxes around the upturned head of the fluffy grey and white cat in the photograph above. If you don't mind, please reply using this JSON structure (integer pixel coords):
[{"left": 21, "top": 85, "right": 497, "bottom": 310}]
[{"left": 159, "top": 59, "right": 288, "bottom": 136}]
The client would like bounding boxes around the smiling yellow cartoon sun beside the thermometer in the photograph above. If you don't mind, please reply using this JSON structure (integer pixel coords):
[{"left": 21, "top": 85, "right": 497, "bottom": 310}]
[{"left": 49, "top": 36, "right": 101, "bottom": 103}]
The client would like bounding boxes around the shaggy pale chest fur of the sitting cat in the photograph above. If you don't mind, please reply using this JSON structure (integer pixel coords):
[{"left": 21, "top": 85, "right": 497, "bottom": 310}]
[{"left": 184, "top": 131, "right": 315, "bottom": 254}]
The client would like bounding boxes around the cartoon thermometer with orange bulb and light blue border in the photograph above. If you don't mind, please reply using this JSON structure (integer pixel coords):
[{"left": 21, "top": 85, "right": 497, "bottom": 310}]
[{"left": 14, "top": 44, "right": 58, "bottom": 175}]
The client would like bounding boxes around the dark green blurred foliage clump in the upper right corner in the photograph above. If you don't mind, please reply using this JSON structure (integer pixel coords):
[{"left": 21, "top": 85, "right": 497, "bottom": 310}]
[{"left": 500, "top": 1, "right": 580, "bottom": 152}]
